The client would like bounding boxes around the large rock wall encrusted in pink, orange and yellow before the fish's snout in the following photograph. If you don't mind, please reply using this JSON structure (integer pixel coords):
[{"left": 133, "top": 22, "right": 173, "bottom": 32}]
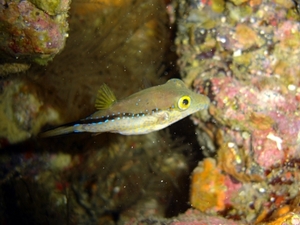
[{"left": 176, "top": 0, "right": 300, "bottom": 224}]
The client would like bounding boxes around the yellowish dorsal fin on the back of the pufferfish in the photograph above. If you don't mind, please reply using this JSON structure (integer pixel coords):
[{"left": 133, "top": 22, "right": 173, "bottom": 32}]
[{"left": 95, "top": 84, "right": 117, "bottom": 110}]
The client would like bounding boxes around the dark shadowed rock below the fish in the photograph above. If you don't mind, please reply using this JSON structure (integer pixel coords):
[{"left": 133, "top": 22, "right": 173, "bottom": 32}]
[{"left": 0, "top": 131, "right": 189, "bottom": 224}]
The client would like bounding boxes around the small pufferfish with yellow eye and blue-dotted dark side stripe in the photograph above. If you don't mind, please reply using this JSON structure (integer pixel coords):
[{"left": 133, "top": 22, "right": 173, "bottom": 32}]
[{"left": 41, "top": 79, "right": 210, "bottom": 137}]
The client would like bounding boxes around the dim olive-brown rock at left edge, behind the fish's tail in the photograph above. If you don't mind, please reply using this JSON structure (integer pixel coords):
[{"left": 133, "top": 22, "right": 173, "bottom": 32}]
[{"left": 0, "top": 79, "right": 61, "bottom": 142}]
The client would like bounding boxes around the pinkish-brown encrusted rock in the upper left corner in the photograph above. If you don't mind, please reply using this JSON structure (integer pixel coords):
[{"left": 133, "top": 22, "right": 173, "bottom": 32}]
[{"left": 0, "top": 0, "right": 71, "bottom": 76}]
